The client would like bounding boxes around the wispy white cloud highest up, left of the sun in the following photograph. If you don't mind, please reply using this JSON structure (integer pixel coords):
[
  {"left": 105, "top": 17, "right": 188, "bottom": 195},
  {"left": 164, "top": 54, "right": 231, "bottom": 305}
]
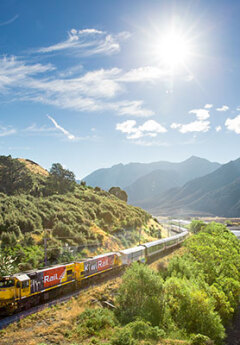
[{"left": 37, "top": 28, "right": 127, "bottom": 56}]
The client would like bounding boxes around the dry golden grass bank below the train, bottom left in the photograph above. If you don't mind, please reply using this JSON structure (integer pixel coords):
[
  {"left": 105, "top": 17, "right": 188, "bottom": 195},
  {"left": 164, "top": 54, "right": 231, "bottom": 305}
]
[{"left": 0, "top": 278, "right": 121, "bottom": 345}]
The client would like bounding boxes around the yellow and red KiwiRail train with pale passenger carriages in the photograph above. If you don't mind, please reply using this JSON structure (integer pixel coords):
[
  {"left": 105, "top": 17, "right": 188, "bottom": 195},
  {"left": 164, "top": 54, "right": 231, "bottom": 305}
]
[{"left": 0, "top": 229, "right": 188, "bottom": 316}]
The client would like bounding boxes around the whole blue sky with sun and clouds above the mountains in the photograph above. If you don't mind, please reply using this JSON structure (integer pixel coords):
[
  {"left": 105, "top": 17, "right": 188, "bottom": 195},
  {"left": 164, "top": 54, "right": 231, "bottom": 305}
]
[{"left": 0, "top": 0, "right": 240, "bottom": 178}]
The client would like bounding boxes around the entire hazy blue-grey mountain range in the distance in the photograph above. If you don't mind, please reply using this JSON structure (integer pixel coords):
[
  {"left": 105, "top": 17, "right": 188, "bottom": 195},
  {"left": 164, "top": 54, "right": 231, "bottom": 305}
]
[{"left": 81, "top": 156, "right": 240, "bottom": 217}]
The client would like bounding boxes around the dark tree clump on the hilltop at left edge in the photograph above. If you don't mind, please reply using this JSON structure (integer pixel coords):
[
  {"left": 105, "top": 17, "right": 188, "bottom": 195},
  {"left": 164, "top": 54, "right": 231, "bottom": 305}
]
[{"left": 0, "top": 156, "right": 34, "bottom": 195}]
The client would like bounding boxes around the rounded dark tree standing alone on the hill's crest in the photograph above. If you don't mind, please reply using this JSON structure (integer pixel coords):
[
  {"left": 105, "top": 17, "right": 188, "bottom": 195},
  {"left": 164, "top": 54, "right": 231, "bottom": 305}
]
[{"left": 46, "top": 163, "right": 76, "bottom": 195}]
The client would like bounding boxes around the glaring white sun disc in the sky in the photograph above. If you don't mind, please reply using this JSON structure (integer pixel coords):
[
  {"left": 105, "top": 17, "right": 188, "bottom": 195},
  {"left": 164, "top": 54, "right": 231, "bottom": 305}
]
[{"left": 153, "top": 30, "right": 191, "bottom": 70}]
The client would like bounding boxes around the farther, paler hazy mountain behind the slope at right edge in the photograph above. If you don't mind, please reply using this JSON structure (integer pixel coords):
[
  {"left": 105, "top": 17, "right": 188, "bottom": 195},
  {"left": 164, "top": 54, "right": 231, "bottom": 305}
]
[{"left": 83, "top": 156, "right": 220, "bottom": 204}]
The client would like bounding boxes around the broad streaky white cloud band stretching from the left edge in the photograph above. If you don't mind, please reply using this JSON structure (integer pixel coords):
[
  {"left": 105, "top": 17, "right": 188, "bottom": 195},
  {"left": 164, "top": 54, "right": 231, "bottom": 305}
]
[{"left": 0, "top": 57, "right": 154, "bottom": 117}]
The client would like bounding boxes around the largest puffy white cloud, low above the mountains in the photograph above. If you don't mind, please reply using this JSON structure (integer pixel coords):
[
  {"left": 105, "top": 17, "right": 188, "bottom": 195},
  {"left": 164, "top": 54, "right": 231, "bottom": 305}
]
[{"left": 116, "top": 120, "right": 167, "bottom": 139}]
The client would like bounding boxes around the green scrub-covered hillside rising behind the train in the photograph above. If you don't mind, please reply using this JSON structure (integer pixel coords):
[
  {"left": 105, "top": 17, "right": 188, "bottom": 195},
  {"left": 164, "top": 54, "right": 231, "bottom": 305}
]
[{"left": 0, "top": 156, "right": 161, "bottom": 270}]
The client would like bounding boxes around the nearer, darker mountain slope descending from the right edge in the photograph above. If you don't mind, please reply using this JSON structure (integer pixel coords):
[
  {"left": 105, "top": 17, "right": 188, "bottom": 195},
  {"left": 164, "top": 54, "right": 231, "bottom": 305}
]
[{"left": 151, "top": 158, "right": 240, "bottom": 217}]
